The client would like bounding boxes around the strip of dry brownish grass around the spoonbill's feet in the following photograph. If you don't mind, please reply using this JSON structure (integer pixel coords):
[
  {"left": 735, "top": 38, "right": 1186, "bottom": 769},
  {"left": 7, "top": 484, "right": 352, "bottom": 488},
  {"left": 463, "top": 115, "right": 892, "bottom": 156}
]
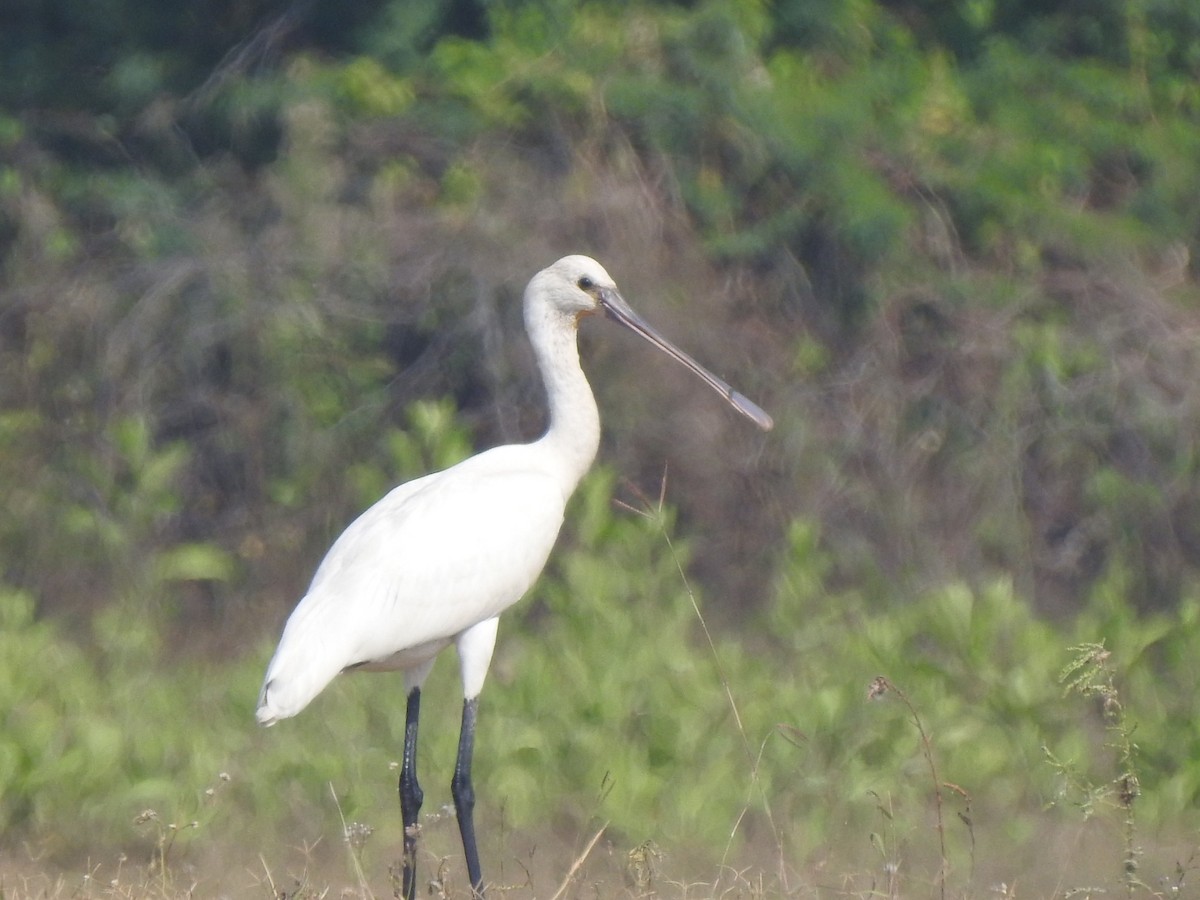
[{"left": 0, "top": 825, "right": 1200, "bottom": 900}]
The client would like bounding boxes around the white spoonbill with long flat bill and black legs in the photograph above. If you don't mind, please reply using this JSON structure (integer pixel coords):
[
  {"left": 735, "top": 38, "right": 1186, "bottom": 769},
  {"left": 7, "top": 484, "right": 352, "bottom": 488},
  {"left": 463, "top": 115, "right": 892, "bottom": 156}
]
[{"left": 257, "top": 256, "right": 772, "bottom": 900}]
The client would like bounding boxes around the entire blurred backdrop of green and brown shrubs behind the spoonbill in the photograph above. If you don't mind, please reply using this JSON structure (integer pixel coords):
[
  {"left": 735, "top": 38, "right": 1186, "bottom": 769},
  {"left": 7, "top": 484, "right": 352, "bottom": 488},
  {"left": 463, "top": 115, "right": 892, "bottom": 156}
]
[{"left": 0, "top": 0, "right": 1200, "bottom": 895}]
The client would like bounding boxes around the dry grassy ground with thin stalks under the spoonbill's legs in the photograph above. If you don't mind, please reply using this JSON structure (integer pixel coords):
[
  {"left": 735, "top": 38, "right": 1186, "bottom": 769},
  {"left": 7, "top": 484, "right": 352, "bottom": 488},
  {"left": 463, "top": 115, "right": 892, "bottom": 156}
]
[{"left": 0, "top": 777, "right": 1200, "bottom": 900}]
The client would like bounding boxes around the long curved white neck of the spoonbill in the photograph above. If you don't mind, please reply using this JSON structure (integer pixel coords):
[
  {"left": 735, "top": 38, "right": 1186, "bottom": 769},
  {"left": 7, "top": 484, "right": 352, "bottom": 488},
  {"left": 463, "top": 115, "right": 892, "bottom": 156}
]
[{"left": 526, "top": 311, "right": 600, "bottom": 494}]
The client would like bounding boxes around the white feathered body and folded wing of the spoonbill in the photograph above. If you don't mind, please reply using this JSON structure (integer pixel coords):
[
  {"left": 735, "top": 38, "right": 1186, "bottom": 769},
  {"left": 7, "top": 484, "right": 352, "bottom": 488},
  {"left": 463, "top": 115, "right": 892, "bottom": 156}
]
[{"left": 258, "top": 446, "right": 565, "bottom": 725}]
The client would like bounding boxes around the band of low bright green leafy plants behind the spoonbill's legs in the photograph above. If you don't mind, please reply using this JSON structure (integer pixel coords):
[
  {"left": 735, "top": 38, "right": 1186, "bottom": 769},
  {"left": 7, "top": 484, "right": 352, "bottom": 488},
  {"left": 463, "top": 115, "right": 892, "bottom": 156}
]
[{"left": 7, "top": 472, "right": 1200, "bottom": 888}]
